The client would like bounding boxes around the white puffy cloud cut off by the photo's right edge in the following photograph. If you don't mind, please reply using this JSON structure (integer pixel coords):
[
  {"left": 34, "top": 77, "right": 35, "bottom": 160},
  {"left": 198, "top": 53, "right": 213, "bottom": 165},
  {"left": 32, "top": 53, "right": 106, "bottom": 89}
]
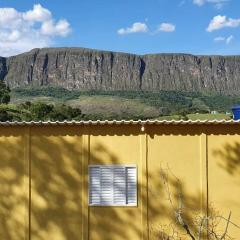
[{"left": 206, "top": 15, "right": 240, "bottom": 32}]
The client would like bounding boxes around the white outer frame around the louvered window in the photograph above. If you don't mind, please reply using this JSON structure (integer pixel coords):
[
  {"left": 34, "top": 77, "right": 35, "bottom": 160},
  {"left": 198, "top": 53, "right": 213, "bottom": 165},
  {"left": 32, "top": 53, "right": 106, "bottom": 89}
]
[{"left": 88, "top": 164, "right": 138, "bottom": 207}]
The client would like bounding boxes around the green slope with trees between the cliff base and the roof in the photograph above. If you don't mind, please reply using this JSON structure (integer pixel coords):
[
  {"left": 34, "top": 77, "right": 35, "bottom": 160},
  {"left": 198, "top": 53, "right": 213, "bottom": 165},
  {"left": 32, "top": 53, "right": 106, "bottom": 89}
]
[{"left": 0, "top": 85, "right": 233, "bottom": 121}]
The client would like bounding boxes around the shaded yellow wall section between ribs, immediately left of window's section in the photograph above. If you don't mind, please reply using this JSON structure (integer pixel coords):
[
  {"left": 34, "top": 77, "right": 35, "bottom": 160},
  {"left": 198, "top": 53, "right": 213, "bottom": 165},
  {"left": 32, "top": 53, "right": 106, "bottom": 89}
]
[{"left": 30, "top": 127, "right": 84, "bottom": 240}]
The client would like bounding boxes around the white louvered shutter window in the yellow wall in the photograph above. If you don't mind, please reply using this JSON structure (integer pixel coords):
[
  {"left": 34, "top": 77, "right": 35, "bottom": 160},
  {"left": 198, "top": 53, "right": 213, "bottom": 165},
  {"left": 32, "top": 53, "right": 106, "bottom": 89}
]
[{"left": 89, "top": 165, "right": 137, "bottom": 206}]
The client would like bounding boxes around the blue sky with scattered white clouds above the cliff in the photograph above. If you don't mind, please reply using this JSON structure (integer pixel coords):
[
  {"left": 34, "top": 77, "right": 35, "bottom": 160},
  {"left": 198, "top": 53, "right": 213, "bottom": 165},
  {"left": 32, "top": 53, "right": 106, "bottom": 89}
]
[{"left": 0, "top": 0, "right": 240, "bottom": 56}]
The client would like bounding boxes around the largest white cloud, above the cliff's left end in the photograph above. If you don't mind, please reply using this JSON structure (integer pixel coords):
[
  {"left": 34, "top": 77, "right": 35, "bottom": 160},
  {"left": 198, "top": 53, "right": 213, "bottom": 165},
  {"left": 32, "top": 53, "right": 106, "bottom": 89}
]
[{"left": 0, "top": 4, "right": 71, "bottom": 56}]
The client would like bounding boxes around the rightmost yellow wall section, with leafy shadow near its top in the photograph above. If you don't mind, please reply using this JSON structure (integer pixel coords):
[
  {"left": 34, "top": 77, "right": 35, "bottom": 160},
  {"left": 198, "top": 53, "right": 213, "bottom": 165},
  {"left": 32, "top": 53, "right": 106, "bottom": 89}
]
[{"left": 208, "top": 127, "right": 240, "bottom": 239}]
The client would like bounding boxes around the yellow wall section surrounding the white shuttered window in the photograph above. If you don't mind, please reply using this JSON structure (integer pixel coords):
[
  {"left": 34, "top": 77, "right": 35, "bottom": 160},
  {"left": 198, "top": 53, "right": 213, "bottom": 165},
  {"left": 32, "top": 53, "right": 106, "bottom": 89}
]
[{"left": 89, "top": 126, "right": 146, "bottom": 240}]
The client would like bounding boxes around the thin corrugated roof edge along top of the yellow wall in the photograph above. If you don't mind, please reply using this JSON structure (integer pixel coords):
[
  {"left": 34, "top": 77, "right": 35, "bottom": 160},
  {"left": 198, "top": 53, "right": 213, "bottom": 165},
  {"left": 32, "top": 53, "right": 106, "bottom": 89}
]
[{"left": 0, "top": 120, "right": 240, "bottom": 126}]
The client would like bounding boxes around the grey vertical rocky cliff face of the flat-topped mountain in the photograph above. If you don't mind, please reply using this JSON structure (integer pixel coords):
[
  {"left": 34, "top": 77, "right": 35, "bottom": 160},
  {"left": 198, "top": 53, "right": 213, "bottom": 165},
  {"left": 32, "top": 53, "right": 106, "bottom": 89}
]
[{"left": 0, "top": 48, "right": 240, "bottom": 93}]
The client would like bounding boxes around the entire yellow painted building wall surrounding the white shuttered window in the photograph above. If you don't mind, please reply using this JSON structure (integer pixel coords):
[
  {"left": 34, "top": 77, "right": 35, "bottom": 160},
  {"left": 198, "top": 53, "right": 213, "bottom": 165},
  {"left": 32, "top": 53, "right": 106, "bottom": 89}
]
[{"left": 0, "top": 125, "right": 240, "bottom": 240}]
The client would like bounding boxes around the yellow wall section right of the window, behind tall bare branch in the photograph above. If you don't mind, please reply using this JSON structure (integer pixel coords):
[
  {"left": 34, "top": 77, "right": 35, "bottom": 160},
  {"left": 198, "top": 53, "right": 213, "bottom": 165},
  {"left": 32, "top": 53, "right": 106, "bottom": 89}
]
[{"left": 148, "top": 126, "right": 207, "bottom": 239}]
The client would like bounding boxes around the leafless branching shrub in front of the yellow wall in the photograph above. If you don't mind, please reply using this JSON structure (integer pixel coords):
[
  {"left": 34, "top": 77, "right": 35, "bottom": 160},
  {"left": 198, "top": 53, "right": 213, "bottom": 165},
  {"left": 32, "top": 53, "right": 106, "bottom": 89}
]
[{"left": 159, "top": 167, "right": 240, "bottom": 240}]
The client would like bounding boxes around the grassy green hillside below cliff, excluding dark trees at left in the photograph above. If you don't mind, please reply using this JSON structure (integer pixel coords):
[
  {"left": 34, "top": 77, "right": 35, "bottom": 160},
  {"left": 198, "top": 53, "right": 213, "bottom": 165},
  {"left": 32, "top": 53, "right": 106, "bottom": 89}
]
[{"left": 11, "top": 87, "right": 240, "bottom": 120}]
